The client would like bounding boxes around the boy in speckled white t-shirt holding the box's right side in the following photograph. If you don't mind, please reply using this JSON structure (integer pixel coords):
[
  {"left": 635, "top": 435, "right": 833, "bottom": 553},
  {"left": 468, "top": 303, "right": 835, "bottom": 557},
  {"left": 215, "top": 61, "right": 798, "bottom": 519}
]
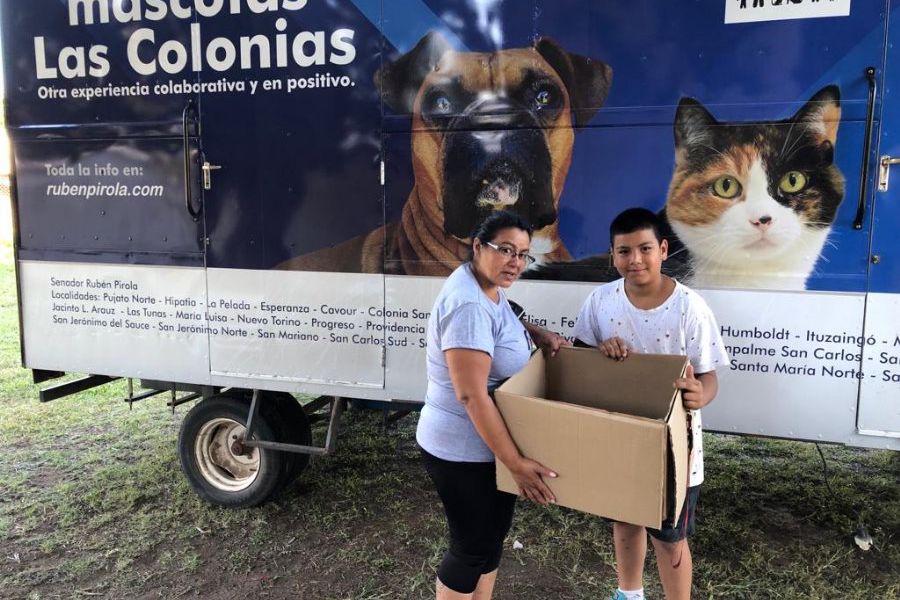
[{"left": 575, "top": 208, "right": 728, "bottom": 600}]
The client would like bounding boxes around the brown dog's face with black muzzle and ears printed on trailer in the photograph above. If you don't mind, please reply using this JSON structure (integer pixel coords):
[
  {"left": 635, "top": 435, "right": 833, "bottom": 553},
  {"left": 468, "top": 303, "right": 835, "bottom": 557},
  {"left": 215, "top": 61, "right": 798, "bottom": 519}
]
[{"left": 376, "top": 33, "right": 612, "bottom": 258}]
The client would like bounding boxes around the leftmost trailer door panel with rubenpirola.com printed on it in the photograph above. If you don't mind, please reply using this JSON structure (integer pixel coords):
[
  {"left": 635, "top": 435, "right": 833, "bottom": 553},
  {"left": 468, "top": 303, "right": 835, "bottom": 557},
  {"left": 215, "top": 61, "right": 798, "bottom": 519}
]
[{"left": 2, "top": 0, "right": 209, "bottom": 383}]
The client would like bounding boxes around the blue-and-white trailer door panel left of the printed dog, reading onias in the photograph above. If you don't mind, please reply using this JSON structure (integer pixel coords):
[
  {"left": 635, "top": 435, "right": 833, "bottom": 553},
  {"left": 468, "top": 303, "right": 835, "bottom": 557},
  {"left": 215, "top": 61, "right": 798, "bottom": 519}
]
[{"left": 200, "top": 1, "right": 385, "bottom": 386}]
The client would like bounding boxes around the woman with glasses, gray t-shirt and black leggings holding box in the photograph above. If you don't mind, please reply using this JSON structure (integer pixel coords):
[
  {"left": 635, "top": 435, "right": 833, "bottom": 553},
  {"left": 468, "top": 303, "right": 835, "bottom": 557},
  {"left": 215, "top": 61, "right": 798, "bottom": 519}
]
[{"left": 416, "top": 212, "right": 567, "bottom": 600}]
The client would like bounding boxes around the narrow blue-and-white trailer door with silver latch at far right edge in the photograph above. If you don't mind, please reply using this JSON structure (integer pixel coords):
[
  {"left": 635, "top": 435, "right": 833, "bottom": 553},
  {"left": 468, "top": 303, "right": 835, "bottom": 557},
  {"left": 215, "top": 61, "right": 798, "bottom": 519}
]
[{"left": 857, "top": 0, "right": 900, "bottom": 444}]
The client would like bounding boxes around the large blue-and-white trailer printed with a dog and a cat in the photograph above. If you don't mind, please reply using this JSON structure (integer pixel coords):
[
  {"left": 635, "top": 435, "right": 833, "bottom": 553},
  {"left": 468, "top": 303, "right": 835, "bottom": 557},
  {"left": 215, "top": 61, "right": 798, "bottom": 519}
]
[{"left": 0, "top": 0, "right": 900, "bottom": 506}]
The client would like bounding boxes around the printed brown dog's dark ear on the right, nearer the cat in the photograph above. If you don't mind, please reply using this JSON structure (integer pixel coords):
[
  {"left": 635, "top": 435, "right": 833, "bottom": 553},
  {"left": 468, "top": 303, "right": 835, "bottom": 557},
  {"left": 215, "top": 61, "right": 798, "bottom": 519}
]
[{"left": 534, "top": 37, "right": 612, "bottom": 127}]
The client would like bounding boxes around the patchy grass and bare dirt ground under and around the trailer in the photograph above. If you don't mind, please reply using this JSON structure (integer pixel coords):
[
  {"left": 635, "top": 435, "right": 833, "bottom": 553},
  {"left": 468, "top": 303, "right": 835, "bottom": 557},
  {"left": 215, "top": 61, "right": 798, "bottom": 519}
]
[{"left": 0, "top": 237, "right": 900, "bottom": 600}]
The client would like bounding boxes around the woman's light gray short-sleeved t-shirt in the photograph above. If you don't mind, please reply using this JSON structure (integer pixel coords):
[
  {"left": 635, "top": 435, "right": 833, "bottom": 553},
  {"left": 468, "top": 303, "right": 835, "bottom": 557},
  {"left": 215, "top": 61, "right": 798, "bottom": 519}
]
[{"left": 416, "top": 263, "right": 531, "bottom": 462}]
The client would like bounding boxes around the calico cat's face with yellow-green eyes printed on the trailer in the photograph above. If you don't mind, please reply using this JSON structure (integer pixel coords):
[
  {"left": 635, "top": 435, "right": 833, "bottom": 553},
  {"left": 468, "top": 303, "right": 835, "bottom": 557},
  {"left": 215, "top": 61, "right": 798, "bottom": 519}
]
[{"left": 666, "top": 86, "right": 844, "bottom": 271}]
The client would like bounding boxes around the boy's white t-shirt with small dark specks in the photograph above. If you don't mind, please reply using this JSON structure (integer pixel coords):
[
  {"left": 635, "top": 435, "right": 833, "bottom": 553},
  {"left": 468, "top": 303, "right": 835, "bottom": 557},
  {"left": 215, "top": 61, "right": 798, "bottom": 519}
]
[{"left": 575, "top": 279, "right": 728, "bottom": 487}]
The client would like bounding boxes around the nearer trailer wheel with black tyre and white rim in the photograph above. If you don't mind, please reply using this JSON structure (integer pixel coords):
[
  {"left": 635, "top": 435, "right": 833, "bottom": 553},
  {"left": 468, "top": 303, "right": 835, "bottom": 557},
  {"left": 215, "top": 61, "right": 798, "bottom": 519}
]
[{"left": 178, "top": 395, "right": 285, "bottom": 508}]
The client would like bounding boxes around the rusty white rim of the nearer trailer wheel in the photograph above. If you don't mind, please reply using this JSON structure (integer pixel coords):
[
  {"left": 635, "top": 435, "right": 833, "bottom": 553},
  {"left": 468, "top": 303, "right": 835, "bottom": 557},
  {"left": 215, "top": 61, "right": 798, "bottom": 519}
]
[{"left": 194, "top": 417, "right": 259, "bottom": 492}]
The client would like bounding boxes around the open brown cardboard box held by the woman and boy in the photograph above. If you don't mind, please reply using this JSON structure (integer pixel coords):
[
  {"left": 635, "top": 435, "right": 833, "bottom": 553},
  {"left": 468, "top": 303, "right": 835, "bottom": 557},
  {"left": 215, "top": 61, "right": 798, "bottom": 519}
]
[{"left": 495, "top": 348, "right": 689, "bottom": 529}]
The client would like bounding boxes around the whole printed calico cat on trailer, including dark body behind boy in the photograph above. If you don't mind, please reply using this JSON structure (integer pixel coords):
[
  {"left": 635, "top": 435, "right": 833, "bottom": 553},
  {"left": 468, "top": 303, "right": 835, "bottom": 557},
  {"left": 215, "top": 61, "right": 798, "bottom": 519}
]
[{"left": 523, "top": 85, "right": 844, "bottom": 290}]
